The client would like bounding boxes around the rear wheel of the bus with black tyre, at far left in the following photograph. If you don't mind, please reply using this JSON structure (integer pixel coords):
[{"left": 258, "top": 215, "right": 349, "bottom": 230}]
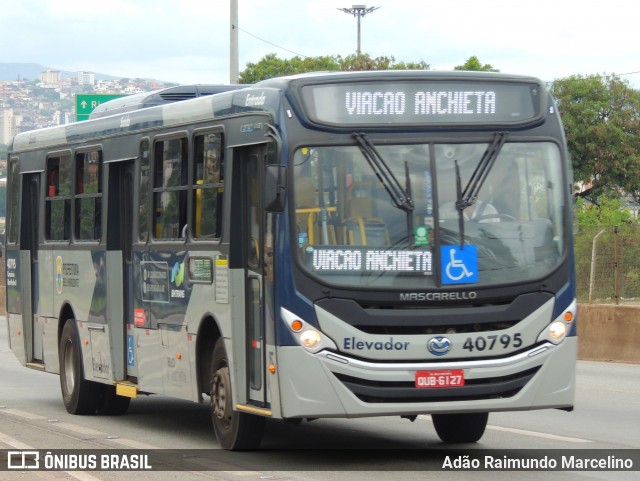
[{"left": 58, "top": 319, "right": 101, "bottom": 414}]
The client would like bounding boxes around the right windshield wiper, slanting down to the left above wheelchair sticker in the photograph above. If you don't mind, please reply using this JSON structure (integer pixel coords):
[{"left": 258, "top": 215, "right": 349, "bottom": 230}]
[{"left": 455, "top": 132, "right": 507, "bottom": 248}]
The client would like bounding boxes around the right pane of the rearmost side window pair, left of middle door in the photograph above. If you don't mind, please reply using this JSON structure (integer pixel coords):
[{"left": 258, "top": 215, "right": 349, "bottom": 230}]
[{"left": 75, "top": 150, "right": 102, "bottom": 240}]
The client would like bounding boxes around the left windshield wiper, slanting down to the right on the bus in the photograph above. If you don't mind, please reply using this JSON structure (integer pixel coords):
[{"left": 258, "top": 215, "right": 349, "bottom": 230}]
[{"left": 353, "top": 132, "right": 415, "bottom": 244}]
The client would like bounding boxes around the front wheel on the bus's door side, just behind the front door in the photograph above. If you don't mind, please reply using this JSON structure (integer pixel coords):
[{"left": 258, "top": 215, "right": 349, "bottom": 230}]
[{"left": 210, "top": 338, "right": 266, "bottom": 450}]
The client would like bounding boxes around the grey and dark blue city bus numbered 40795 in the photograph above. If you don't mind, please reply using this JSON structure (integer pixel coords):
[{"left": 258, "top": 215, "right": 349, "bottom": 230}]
[{"left": 5, "top": 71, "right": 577, "bottom": 450}]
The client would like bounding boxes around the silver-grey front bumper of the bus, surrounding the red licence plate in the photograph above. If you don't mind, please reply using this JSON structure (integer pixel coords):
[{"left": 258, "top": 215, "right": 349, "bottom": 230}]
[{"left": 278, "top": 337, "right": 577, "bottom": 418}]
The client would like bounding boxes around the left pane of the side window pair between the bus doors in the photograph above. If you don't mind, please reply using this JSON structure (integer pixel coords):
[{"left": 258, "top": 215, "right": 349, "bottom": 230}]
[{"left": 153, "top": 138, "right": 187, "bottom": 239}]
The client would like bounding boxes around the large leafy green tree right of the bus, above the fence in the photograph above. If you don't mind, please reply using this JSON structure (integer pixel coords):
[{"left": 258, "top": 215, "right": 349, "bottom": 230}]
[{"left": 551, "top": 75, "right": 640, "bottom": 204}]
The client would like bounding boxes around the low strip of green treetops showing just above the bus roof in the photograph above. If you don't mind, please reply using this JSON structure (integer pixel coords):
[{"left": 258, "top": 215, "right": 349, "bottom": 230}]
[{"left": 240, "top": 53, "right": 429, "bottom": 84}]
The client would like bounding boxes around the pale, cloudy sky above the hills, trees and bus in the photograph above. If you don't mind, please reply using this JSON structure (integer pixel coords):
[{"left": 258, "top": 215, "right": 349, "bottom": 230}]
[{"left": 0, "top": 0, "right": 640, "bottom": 89}]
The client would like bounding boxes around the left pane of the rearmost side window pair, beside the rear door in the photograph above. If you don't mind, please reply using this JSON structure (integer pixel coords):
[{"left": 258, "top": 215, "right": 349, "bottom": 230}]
[{"left": 46, "top": 154, "right": 72, "bottom": 241}]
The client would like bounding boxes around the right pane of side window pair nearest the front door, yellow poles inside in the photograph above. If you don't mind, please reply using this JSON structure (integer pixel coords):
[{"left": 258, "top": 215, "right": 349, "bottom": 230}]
[{"left": 192, "top": 133, "right": 224, "bottom": 239}]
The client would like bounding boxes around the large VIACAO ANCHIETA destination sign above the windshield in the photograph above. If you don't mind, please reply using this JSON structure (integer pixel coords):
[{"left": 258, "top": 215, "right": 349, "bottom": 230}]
[{"left": 302, "top": 80, "right": 542, "bottom": 126}]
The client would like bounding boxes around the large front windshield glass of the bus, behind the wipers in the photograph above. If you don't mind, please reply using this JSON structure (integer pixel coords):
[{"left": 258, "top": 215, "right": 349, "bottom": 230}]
[{"left": 293, "top": 142, "right": 565, "bottom": 289}]
